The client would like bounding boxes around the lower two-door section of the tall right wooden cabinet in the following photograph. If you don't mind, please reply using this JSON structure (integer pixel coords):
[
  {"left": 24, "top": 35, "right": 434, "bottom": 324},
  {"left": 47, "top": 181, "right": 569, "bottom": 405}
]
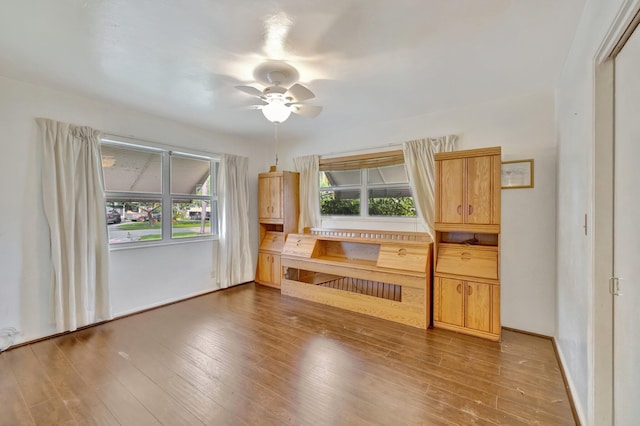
[{"left": 433, "top": 276, "right": 500, "bottom": 340}]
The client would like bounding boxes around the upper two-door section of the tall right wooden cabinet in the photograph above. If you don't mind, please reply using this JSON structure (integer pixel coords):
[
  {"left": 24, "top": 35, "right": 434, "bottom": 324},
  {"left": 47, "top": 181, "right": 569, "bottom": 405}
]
[{"left": 435, "top": 147, "right": 501, "bottom": 232}]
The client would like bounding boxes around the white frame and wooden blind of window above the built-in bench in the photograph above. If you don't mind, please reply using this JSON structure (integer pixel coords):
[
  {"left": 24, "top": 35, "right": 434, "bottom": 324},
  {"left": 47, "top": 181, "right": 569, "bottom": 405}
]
[{"left": 318, "top": 150, "right": 417, "bottom": 220}]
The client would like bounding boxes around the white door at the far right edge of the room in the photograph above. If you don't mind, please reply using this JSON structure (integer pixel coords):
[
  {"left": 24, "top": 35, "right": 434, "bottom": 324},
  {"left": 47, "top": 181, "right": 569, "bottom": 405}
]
[{"left": 612, "top": 20, "right": 640, "bottom": 426}]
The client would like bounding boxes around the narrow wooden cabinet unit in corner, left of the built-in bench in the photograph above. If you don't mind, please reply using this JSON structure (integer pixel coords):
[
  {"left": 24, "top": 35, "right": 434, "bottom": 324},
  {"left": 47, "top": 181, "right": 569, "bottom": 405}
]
[{"left": 256, "top": 171, "right": 300, "bottom": 288}]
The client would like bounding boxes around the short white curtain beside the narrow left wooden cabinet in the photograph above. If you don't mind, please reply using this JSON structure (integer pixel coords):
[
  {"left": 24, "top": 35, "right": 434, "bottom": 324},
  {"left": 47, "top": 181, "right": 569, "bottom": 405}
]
[{"left": 293, "top": 155, "right": 321, "bottom": 233}]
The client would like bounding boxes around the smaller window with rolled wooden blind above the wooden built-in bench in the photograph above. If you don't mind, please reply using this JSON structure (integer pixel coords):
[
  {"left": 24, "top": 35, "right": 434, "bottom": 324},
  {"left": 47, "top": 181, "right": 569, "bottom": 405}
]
[{"left": 320, "top": 151, "right": 416, "bottom": 217}]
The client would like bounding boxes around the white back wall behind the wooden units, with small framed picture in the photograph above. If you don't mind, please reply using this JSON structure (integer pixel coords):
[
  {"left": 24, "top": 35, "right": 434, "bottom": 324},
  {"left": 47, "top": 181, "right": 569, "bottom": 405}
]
[{"left": 282, "top": 92, "right": 556, "bottom": 335}]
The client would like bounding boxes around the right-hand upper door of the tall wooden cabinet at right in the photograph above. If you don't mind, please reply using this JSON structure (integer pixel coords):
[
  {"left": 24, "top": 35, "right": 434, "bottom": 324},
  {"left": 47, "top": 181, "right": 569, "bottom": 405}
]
[{"left": 465, "top": 156, "right": 494, "bottom": 224}]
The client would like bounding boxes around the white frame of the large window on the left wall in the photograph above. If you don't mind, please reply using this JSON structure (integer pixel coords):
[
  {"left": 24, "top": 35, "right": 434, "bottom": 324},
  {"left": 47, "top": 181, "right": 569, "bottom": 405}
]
[{"left": 100, "top": 135, "right": 220, "bottom": 250}]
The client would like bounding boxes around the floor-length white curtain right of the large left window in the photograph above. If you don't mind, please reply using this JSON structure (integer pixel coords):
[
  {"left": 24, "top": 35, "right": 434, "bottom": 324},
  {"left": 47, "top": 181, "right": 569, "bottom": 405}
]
[{"left": 217, "top": 151, "right": 254, "bottom": 288}]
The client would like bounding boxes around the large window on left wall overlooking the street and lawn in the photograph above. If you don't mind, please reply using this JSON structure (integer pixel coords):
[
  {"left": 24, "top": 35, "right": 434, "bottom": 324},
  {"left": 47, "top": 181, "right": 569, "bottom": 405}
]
[{"left": 101, "top": 140, "right": 218, "bottom": 244}]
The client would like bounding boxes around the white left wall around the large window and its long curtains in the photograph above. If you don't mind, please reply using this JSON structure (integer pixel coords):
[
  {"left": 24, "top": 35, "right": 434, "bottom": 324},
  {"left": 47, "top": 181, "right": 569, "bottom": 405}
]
[{"left": 0, "top": 78, "right": 272, "bottom": 343}]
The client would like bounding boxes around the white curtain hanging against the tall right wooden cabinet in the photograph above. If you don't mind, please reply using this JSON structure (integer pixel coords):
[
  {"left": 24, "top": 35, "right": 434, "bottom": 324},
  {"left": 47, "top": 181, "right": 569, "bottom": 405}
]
[{"left": 402, "top": 135, "right": 458, "bottom": 238}]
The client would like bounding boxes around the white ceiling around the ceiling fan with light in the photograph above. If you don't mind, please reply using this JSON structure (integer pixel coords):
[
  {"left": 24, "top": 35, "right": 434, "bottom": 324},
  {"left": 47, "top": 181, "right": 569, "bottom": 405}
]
[{"left": 0, "top": 0, "right": 584, "bottom": 142}]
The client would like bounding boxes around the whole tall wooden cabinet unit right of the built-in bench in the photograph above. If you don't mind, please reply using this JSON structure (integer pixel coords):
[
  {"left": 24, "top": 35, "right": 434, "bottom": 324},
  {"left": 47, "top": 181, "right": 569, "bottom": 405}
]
[{"left": 433, "top": 147, "right": 501, "bottom": 340}]
